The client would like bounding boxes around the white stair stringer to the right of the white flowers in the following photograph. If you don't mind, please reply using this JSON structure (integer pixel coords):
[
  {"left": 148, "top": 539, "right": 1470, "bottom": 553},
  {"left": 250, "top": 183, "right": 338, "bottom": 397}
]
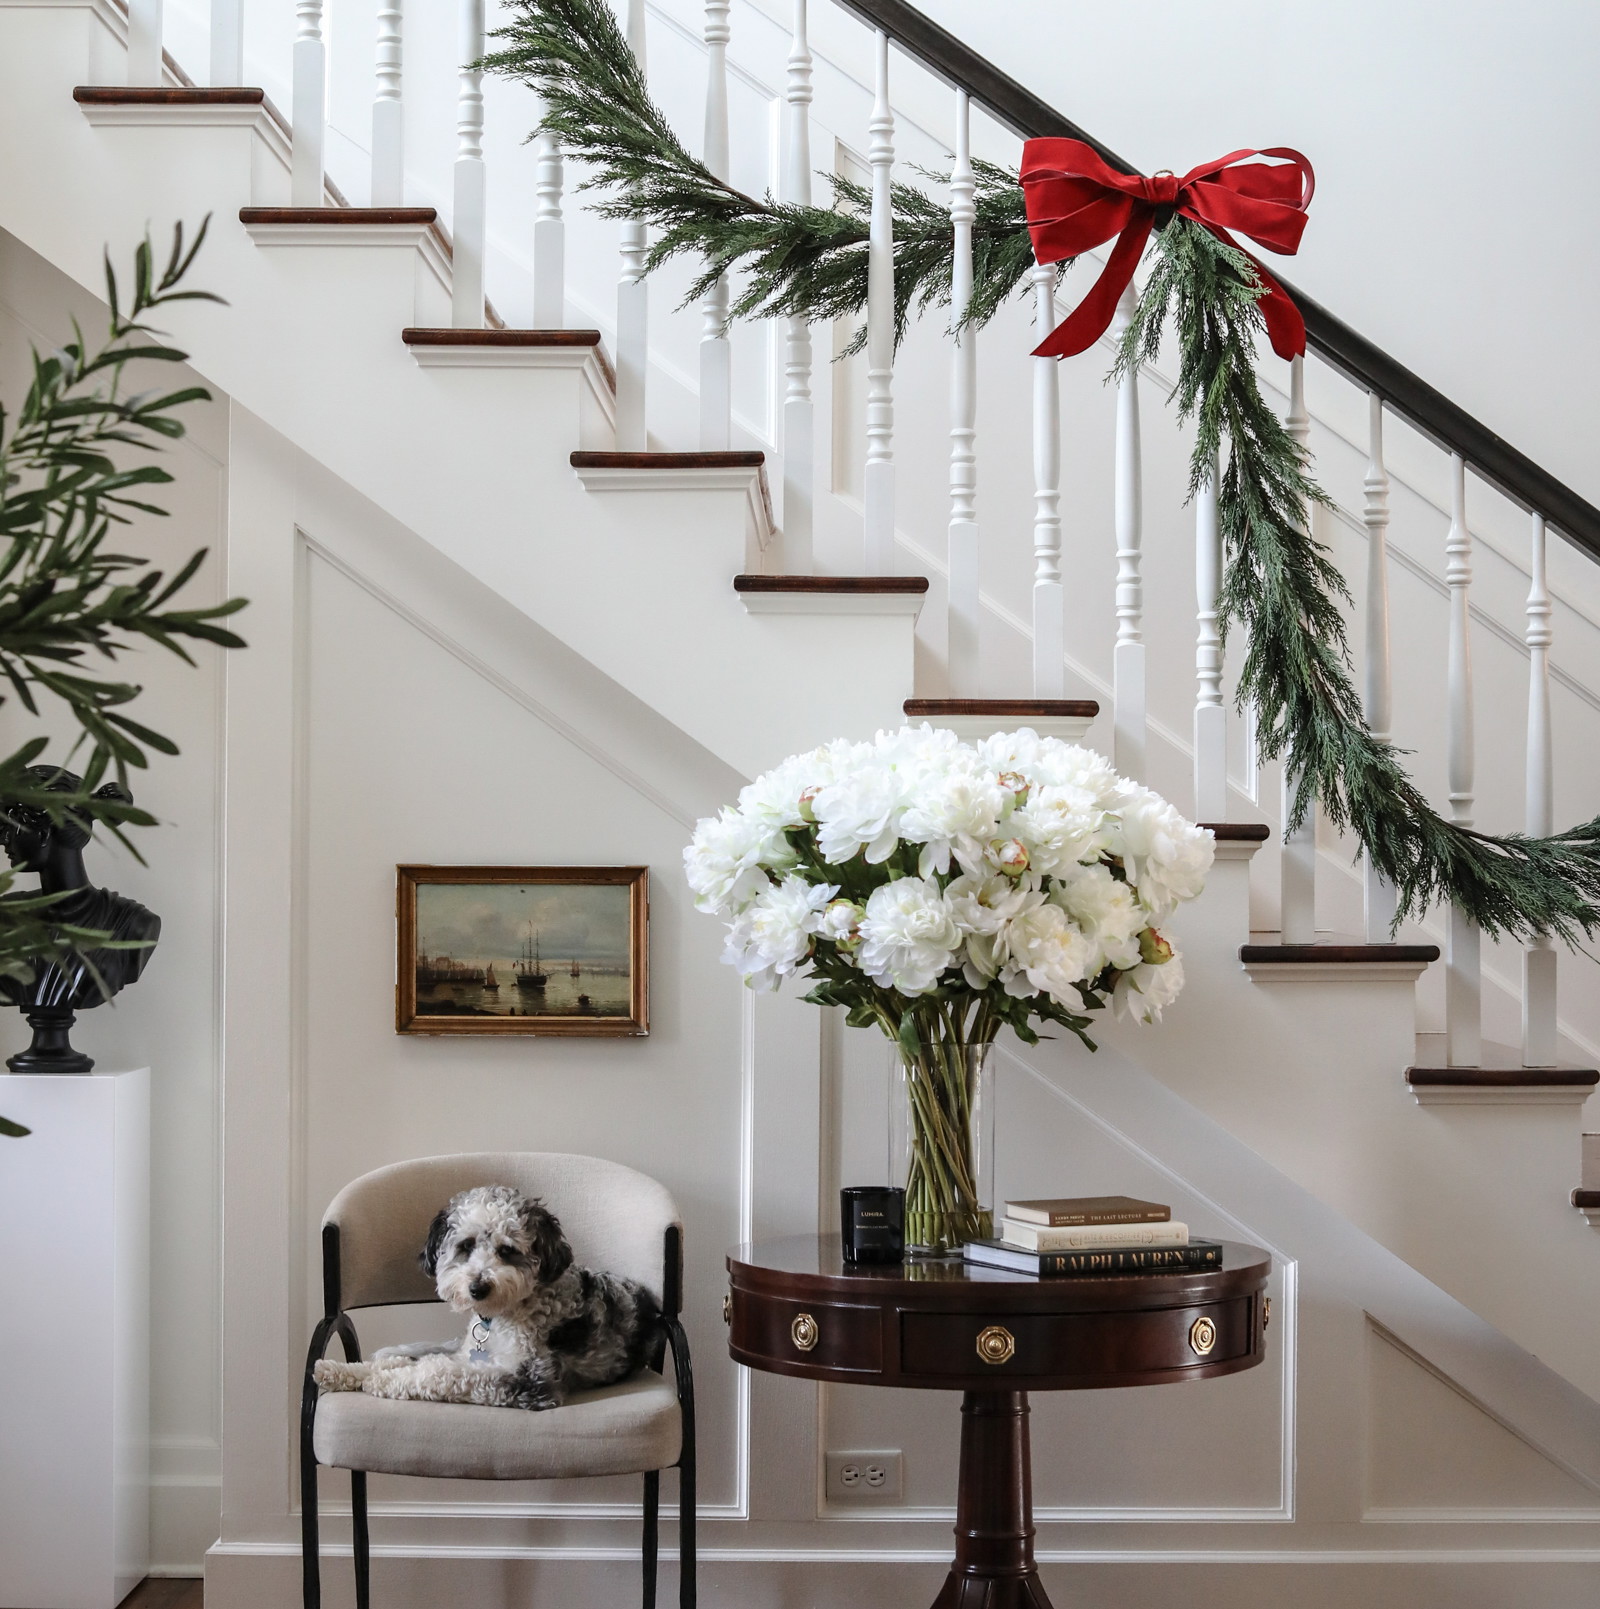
[{"left": 1094, "top": 858, "right": 1600, "bottom": 1397}]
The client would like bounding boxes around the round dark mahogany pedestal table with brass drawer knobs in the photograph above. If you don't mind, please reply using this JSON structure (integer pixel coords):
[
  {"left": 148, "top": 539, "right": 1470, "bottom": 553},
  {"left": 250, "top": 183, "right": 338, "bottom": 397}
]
[{"left": 728, "top": 1236, "right": 1272, "bottom": 1609}]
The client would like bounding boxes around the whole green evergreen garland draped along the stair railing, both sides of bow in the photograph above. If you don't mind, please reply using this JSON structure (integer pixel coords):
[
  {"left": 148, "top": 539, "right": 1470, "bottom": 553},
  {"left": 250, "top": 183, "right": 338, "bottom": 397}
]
[{"left": 481, "top": 0, "right": 1600, "bottom": 944}]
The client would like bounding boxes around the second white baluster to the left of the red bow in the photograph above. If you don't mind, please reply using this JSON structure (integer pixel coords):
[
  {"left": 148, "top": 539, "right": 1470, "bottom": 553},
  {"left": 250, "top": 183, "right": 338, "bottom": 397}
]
[{"left": 861, "top": 32, "right": 897, "bottom": 576}]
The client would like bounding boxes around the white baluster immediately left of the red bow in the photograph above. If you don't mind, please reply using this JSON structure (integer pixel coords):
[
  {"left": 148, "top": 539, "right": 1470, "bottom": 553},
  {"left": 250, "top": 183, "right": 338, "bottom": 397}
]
[{"left": 945, "top": 90, "right": 980, "bottom": 698}]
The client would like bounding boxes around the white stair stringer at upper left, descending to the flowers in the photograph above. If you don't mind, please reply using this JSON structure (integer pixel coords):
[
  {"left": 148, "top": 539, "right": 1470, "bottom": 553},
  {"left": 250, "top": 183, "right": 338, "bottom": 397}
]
[{"left": 0, "top": 0, "right": 914, "bottom": 776}]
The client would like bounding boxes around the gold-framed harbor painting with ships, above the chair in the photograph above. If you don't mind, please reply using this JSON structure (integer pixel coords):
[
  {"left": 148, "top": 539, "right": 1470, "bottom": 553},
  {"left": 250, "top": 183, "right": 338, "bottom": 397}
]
[{"left": 394, "top": 866, "right": 650, "bottom": 1036}]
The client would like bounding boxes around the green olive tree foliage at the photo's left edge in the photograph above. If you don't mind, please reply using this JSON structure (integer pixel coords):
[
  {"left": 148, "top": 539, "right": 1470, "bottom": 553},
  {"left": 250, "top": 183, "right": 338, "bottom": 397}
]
[{"left": 0, "top": 220, "right": 245, "bottom": 1134}]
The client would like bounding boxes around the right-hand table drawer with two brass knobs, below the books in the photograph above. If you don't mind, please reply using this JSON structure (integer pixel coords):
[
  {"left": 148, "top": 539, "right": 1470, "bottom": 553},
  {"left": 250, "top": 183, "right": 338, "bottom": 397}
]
[{"left": 900, "top": 1297, "right": 1256, "bottom": 1379}]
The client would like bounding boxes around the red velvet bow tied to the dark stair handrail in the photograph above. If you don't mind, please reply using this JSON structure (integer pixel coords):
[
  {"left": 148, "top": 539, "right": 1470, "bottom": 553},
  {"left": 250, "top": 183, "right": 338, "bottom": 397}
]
[{"left": 1022, "top": 138, "right": 1317, "bottom": 357}]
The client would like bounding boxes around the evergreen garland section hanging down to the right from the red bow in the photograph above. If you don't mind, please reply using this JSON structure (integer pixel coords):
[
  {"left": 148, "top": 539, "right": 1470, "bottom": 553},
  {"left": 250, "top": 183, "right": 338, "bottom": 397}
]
[{"left": 1117, "top": 217, "right": 1600, "bottom": 944}]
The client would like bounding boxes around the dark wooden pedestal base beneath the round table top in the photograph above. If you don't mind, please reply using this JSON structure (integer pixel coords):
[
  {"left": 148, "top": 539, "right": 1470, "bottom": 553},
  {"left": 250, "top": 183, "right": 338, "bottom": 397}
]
[{"left": 934, "top": 1392, "right": 1051, "bottom": 1609}]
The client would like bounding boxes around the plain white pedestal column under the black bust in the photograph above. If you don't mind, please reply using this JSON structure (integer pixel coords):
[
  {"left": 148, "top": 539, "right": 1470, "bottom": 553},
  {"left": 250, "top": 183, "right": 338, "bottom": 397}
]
[{"left": 0, "top": 1067, "right": 150, "bottom": 1609}]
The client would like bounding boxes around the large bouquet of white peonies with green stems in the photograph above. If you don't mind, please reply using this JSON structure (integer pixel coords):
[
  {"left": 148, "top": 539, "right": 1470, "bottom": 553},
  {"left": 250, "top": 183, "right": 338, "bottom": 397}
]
[{"left": 684, "top": 726, "right": 1214, "bottom": 1249}]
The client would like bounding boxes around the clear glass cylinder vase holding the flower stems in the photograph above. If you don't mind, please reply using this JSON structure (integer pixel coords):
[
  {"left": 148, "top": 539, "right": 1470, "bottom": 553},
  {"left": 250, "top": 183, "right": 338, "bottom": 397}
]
[{"left": 889, "top": 1035, "right": 995, "bottom": 1257}]
